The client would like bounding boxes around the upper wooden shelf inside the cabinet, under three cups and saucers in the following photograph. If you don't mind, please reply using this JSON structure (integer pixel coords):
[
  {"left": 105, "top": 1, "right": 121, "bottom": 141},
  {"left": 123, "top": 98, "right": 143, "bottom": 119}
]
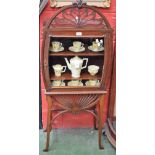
[{"left": 49, "top": 50, "right": 104, "bottom": 56}]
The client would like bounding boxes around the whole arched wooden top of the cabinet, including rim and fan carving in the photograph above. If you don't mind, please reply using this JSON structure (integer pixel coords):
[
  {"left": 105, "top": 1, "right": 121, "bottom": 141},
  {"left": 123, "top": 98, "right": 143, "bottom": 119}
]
[{"left": 46, "top": 4, "right": 111, "bottom": 30}]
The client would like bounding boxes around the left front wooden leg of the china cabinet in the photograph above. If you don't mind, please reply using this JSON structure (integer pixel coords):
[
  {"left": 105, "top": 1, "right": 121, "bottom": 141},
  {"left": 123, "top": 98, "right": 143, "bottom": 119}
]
[{"left": 43, "top": 96, "right": 52, "bottom": 152}]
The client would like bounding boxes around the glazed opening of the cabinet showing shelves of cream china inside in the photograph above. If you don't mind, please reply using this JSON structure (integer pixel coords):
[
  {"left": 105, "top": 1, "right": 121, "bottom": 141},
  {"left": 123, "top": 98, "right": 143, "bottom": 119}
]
[{"left": 48, "top": 36, "right": 104, "bottom": 89}]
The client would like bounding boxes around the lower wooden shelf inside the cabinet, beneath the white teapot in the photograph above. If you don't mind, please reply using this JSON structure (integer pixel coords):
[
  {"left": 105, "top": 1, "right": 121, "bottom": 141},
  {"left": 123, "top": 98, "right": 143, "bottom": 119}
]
[{"left": 50, "top": 73, "right": 101, "bottom": 80}]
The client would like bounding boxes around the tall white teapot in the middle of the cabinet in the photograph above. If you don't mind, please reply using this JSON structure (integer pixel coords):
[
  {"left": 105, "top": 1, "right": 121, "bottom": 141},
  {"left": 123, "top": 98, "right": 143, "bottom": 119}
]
[{"left": 65, "top": 56, "right": 88, "bottom": 78}]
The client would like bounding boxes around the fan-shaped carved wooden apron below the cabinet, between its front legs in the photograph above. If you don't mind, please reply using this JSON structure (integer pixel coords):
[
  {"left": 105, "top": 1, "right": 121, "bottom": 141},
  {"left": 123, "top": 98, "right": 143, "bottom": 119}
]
[{"left": 53, "top": 94, "right": 99, "bottom": 113}]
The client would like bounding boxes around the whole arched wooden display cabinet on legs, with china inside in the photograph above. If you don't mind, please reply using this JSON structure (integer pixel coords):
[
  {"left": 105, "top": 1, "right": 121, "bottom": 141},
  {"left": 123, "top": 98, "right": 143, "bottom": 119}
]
[{"left": 41, "top": 1, "right": 113, "bottom": 151}]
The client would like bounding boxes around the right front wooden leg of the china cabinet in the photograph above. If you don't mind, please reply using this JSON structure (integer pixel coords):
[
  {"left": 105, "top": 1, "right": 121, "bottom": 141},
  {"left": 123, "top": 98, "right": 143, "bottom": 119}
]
[{"left": 98, "top": 95, "right": 104, "bottom": 149}]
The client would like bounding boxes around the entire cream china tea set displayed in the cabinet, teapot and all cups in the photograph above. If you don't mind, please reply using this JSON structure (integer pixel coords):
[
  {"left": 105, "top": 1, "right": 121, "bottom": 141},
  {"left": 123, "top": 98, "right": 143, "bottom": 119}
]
[{"left": 50, "top": 39, "right": 104, "bottom": 86}]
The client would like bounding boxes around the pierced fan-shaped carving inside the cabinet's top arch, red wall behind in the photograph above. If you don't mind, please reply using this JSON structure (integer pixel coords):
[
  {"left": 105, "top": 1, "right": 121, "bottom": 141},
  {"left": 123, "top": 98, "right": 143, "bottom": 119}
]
[{"left": 51, "top": 7, "right": 107, "bottom": 29}]
